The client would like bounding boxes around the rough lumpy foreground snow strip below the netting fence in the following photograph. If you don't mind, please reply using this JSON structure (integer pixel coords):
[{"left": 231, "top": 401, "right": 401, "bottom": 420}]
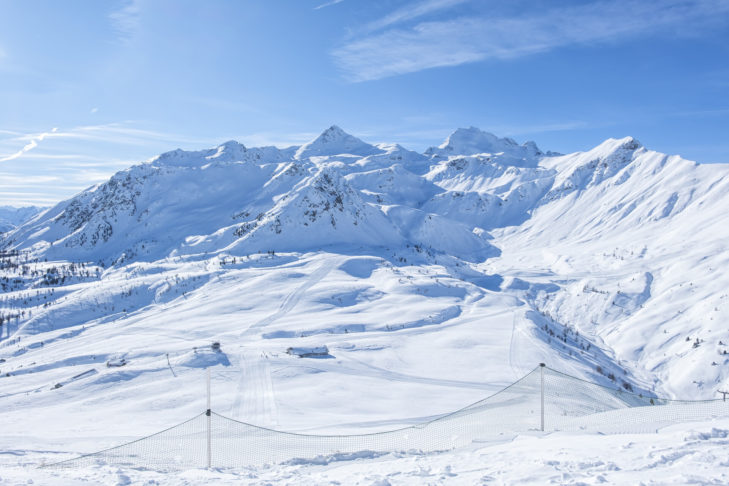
[{"left": 0, "top": 419, "right": 729, "bottom": 486}]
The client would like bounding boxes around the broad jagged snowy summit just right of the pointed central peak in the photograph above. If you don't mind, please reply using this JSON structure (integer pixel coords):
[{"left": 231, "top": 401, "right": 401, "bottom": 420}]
[{"left": 425, "top": 127, "right": 544, "bottom": 158}]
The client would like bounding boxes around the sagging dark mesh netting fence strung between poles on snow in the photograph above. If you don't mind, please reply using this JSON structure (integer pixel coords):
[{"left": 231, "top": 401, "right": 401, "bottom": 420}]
[{"left": 46, "top": 367, "right": 729, "bottom": 470}]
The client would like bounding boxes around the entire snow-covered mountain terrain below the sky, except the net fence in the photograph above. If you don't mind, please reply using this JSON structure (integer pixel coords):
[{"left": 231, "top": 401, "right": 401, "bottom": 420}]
[{"left": 0, "top": 126, "right": 729, "bottom": 485}]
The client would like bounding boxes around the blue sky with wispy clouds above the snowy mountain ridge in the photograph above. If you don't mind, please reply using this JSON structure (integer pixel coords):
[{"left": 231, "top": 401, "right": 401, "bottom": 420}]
[{"left": 0, "top": 0, "right": 729, "bottom": 205}]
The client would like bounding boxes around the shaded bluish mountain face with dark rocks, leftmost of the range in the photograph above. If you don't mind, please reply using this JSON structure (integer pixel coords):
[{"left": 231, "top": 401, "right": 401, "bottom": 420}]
[{"left": 7, "top": 145, "right": 290, "bottom": 263}]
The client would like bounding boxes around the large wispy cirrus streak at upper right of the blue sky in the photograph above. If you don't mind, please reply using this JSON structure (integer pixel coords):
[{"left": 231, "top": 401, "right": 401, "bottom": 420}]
[{"left": 332, "top": 0, "right": 729, "bottom": 82}]
